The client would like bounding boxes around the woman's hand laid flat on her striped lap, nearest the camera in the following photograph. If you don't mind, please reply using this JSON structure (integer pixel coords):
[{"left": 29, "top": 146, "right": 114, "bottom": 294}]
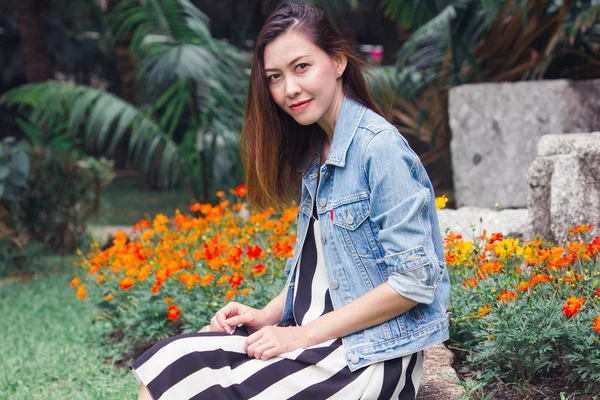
[{"left": 245, "top": 326, "right": 310, "bottom": 360}]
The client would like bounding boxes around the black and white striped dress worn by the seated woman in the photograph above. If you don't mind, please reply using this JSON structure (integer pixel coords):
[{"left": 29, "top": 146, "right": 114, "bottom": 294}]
[{"left": 129, "top": 200, "right": 423, "bottom": 400}]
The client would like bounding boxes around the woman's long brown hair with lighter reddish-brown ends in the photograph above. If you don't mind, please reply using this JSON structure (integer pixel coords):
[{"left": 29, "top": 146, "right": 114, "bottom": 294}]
[{"left": 240, "top": 2, "right": 386, "bottom": 209}]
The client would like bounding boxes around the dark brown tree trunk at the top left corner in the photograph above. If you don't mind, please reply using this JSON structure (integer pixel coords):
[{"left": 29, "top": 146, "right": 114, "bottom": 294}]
[{"left": 15, "top": 0, "right": 51, "bottom": 83}]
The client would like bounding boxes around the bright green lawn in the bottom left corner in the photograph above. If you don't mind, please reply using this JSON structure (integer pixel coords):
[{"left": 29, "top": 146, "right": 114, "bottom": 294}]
[{"left": 0, "top": 257, "right": 138, "bottom": 400}]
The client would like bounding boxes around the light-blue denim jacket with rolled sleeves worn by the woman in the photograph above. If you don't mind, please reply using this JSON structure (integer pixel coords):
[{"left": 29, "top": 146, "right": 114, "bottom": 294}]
[{"left": 278, "top": 96, "right": 450, "bottom": 371}]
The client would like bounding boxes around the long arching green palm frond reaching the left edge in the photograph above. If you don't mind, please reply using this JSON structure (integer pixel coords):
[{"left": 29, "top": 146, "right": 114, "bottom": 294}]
[{"left": 0, "top": 81, "right": 180, "bottom": 186}]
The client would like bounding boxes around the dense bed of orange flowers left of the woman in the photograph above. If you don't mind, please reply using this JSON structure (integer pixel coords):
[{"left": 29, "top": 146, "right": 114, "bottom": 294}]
[{"left": 71, "top": 185, "right": 297, "bottom": 354}]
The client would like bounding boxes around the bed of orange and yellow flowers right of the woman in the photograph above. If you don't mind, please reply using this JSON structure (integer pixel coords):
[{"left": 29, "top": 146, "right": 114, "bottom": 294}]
[{"left": 444, "top": 225, "right": 600, "bottom": 391}]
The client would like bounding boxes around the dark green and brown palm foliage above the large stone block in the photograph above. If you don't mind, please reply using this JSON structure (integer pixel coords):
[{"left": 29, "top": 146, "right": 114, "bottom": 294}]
[{"left": 372, "top": 0, "right": 600, "bottom": 164}]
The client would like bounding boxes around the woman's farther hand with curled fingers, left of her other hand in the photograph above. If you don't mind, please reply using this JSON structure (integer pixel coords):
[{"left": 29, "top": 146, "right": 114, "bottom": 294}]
[{"left": 210, "top": 301, "right": 270, "bottom": 333}]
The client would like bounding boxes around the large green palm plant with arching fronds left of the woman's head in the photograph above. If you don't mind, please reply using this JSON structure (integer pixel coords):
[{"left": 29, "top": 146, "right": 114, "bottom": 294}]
[{"left": 3, "top": 0, "right": 249, "bottom": 200}]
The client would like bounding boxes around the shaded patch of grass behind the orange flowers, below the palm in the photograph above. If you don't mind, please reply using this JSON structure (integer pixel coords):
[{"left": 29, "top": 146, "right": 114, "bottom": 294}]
[{"left": 87, "top": 178, "right": 191, "bottom": 225}]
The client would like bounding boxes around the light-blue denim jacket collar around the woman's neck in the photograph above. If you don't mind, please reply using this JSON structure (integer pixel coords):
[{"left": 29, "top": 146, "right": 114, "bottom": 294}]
[{"left": 297, "top": 95, "right": 366, "bottom": 172}]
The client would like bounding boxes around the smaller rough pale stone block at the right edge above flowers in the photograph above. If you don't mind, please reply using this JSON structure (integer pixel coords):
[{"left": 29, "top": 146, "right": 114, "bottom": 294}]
[{"left": 528, "top": 132, "right": 600, "bottom": 243}]
